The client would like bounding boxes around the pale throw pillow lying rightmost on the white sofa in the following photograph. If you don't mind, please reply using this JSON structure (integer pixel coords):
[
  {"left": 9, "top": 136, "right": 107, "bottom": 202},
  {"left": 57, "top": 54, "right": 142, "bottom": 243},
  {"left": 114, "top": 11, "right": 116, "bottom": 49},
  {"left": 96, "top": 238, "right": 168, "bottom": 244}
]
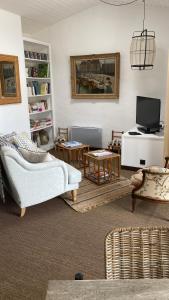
[{"left": 18, "top": 147, "right": 48, "bottom": 163}]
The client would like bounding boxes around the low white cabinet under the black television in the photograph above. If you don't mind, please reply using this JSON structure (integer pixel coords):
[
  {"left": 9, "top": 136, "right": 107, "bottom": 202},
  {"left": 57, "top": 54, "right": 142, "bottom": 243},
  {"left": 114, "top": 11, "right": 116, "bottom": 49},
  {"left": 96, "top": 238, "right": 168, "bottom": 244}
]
[{"left": 121, "top": 128, "right": 164, "bottom": 168}]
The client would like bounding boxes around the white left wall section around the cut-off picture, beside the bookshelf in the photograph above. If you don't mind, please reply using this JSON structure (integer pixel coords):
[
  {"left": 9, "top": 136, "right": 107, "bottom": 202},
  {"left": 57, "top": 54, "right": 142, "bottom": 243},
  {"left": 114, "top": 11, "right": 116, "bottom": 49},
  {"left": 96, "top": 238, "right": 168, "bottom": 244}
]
[{"left": 0, "top": 10, "right": 29, "bottom": 133}]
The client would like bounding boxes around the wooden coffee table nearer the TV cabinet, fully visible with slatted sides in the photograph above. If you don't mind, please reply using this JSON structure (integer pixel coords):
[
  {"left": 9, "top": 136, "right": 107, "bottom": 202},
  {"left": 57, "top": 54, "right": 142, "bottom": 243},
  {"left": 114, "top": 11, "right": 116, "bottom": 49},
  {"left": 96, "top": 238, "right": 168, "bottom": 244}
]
[{"left": 84, "top": 151, "right": 120, "bottom": 185}]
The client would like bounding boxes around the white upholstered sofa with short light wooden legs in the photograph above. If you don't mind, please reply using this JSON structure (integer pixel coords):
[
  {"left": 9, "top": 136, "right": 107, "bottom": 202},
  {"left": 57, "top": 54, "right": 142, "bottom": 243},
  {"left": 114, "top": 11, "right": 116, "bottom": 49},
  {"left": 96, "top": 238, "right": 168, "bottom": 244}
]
[{"left": 1, "top": 146, "right": 81, "bottom": 217}]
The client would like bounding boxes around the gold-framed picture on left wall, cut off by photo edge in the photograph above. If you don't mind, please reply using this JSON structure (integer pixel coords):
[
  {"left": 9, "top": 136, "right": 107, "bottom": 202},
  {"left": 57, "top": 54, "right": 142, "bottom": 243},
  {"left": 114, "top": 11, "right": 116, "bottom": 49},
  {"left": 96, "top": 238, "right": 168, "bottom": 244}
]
[{"left": 0, "top": 54, "right": 21, "bottom": 105}]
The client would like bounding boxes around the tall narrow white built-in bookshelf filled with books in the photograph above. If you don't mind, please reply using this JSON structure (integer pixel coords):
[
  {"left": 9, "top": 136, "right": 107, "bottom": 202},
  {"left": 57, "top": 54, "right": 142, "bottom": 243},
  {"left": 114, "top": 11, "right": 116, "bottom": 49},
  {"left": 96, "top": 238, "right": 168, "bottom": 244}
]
[{"left": 23, "top": 38, "right": 55, "bottom": 150}]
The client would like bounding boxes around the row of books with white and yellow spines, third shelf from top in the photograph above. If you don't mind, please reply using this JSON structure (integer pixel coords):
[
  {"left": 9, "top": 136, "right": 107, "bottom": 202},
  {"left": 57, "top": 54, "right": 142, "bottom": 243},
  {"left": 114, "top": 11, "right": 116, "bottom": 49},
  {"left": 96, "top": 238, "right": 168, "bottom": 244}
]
[{"left": 27, "top": 81, "right": 50, "bottom": 97}]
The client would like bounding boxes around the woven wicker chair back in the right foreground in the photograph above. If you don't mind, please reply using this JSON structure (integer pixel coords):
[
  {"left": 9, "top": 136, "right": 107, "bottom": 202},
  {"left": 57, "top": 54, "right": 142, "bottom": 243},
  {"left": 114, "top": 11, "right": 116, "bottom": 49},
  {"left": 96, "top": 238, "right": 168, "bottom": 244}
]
[{"left": 105, "top": 227, "right": 169, "bottom": 279}]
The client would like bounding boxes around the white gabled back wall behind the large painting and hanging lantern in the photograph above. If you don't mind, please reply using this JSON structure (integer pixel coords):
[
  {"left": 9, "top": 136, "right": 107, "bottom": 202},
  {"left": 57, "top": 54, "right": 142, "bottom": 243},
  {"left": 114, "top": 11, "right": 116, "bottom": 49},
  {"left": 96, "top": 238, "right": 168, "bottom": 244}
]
[{"left": 33, "top": 4, "right": 169, "bottom": 146}]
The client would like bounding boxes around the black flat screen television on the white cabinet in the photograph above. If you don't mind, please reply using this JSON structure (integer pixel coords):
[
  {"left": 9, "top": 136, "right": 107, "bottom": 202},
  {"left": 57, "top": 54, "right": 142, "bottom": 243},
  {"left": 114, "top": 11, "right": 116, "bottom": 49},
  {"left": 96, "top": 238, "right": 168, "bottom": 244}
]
[{"left": 136, "top": 96, "right": 161, "bottom": 133}]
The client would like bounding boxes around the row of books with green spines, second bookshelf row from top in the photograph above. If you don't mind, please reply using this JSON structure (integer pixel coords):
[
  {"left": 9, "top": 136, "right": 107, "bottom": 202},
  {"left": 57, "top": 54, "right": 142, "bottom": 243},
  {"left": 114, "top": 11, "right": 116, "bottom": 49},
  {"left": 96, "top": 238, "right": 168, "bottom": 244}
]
[{"left": 26, "top": 64, "right": 49, "bottom": 78}]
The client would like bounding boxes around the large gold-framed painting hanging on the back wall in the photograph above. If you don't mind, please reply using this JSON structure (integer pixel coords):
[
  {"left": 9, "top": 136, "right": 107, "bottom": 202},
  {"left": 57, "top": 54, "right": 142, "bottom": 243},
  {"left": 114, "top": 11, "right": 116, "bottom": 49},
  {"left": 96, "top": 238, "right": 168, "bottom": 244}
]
[{"left": 70, "top": 53, "right": 120, "bottom": 99}]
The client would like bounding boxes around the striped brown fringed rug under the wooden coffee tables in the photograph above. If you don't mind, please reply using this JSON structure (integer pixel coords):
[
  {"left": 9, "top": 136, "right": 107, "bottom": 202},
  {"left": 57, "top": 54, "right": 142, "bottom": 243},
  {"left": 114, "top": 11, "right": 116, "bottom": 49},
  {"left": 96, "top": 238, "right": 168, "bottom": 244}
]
[{"left": 62, "top": 177, "right": 132, "bottom": 213}]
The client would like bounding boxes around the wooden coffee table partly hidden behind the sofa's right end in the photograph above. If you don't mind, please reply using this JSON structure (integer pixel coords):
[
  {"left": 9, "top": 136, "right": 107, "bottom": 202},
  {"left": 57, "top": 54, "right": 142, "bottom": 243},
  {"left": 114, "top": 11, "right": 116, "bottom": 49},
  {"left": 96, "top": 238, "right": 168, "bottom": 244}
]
[{"left": 55, "top": 144, "right": 89, "bottom": 168}]
